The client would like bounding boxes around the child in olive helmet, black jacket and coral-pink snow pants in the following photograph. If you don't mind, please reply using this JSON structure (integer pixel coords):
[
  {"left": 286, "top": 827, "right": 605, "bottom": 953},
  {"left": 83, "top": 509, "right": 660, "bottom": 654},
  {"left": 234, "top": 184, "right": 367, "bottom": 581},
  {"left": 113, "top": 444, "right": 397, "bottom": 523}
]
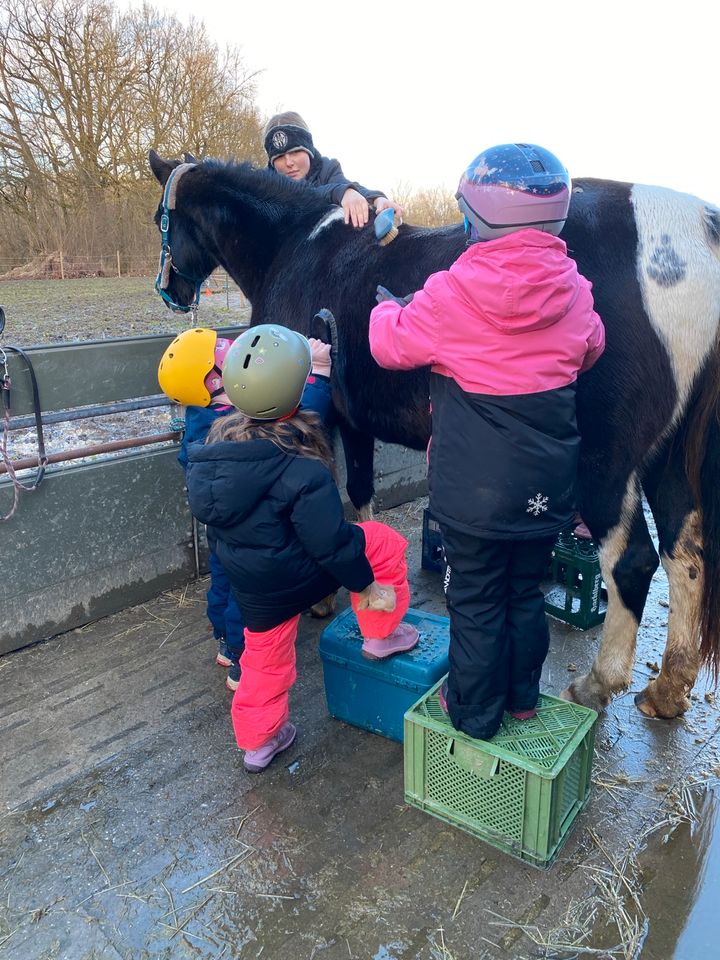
[{"left": 188, "top": 324, "right": 418, "bottom": 772}]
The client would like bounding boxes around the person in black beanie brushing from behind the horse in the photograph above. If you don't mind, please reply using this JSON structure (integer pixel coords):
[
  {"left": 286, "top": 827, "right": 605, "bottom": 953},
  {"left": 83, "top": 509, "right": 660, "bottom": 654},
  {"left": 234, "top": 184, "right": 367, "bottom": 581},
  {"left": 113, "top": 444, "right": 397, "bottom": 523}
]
[{"left": 264, "top": 111, "right": 402, "bottom": 227}]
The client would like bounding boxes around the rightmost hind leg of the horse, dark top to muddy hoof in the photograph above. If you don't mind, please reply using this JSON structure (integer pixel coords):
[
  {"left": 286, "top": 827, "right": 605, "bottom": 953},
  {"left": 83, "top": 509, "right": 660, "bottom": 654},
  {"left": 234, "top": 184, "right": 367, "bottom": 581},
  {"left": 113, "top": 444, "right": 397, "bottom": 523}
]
[{"left": 635, "top": 447, "right": 703, "bottom": 718}]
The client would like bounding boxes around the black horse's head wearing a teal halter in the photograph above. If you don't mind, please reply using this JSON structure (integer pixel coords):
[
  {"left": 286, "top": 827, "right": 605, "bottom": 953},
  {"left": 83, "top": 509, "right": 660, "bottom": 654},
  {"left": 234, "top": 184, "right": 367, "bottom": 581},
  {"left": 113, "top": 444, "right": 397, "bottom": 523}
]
[{"left": 148, "top": 150, "right": 218, "bottom": 313}]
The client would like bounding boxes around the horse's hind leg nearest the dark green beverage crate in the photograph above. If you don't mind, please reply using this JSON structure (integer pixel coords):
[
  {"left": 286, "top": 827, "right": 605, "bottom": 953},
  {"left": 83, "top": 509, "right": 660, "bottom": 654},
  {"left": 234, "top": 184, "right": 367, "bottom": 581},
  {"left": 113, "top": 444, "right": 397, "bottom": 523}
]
[{"left": 562, "top": 471, "right": 658, "bottom": 711}]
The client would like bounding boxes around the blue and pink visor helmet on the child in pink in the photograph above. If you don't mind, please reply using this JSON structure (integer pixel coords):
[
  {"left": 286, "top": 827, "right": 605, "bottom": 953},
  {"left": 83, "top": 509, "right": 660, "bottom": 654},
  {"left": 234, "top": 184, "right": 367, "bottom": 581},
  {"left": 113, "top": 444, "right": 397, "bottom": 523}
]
[{"left": 455, "top": 143, "right": 571, "bottom": 240}]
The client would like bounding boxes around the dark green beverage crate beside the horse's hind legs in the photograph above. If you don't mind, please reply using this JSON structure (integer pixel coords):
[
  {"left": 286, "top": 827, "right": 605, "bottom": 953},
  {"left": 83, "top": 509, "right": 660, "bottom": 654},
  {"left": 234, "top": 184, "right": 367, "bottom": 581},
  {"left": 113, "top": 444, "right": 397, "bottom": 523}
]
[{"left": 545, "top": 533, "right": 607, "bottom": 630}]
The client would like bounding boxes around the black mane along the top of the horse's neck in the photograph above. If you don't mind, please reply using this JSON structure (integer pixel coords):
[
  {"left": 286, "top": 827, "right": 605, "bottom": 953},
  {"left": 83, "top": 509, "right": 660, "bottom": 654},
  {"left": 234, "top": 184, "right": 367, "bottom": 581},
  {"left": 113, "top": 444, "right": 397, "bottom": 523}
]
[{"left": 187, "top": 159, "right": 331, "bottom": 217}]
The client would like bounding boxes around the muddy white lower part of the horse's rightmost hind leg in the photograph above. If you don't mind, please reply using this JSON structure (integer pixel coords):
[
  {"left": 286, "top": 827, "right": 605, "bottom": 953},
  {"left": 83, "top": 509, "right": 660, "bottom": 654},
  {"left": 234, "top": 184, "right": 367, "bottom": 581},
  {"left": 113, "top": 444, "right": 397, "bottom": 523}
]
[{"left": 635, "top": 511, "right": 703, "bottom": 717}]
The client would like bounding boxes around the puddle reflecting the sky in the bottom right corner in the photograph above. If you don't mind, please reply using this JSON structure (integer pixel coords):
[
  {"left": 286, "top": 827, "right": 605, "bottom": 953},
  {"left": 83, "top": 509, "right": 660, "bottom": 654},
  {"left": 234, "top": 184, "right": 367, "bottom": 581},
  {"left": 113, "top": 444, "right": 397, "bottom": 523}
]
[{"left": 639, "top": 786, "right": 720, "bottom": 960}]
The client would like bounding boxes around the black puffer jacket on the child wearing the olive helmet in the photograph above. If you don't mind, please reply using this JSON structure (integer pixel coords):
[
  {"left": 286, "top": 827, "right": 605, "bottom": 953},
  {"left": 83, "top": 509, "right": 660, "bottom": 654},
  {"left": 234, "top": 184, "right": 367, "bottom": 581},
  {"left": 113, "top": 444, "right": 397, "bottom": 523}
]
[{"left": 187, "top": 439, "right": 373, "bottom": 631}]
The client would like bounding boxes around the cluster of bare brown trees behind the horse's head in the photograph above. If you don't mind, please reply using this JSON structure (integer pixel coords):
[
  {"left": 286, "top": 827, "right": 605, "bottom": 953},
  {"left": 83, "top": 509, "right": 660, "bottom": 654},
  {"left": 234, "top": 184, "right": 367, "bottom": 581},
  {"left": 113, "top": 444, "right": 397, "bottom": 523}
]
[{"left": 0, "top": 0, "right": 261, "bottom": 262}]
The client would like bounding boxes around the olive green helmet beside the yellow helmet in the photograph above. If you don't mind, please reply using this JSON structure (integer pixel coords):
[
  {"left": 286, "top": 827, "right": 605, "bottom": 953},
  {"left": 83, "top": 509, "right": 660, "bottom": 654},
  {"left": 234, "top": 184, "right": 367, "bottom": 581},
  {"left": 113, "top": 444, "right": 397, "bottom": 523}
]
[{"left": 223, "top": 323, "right": 311, "bottom": 420}]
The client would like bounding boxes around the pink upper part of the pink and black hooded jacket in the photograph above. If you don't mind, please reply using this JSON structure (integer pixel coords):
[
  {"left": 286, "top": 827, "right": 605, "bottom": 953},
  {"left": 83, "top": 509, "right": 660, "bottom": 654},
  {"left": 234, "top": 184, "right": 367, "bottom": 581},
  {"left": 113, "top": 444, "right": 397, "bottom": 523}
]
[{"left": 370, "top": 229, "right": 605, "bottom": 396}]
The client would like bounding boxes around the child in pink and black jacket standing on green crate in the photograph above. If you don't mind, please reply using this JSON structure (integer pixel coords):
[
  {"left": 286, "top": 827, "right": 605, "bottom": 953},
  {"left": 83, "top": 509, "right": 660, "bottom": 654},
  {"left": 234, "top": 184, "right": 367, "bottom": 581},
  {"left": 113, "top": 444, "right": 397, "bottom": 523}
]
[{"left": 370, "top": 144, "right": 605, "bottom": 739}]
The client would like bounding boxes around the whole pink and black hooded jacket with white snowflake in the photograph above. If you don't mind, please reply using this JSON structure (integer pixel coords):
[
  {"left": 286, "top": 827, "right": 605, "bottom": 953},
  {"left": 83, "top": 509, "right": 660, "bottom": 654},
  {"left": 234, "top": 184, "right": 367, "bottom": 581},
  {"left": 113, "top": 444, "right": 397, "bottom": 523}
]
[{"left": 370, "top": 229, "right": 605, "bottom": 539}]
